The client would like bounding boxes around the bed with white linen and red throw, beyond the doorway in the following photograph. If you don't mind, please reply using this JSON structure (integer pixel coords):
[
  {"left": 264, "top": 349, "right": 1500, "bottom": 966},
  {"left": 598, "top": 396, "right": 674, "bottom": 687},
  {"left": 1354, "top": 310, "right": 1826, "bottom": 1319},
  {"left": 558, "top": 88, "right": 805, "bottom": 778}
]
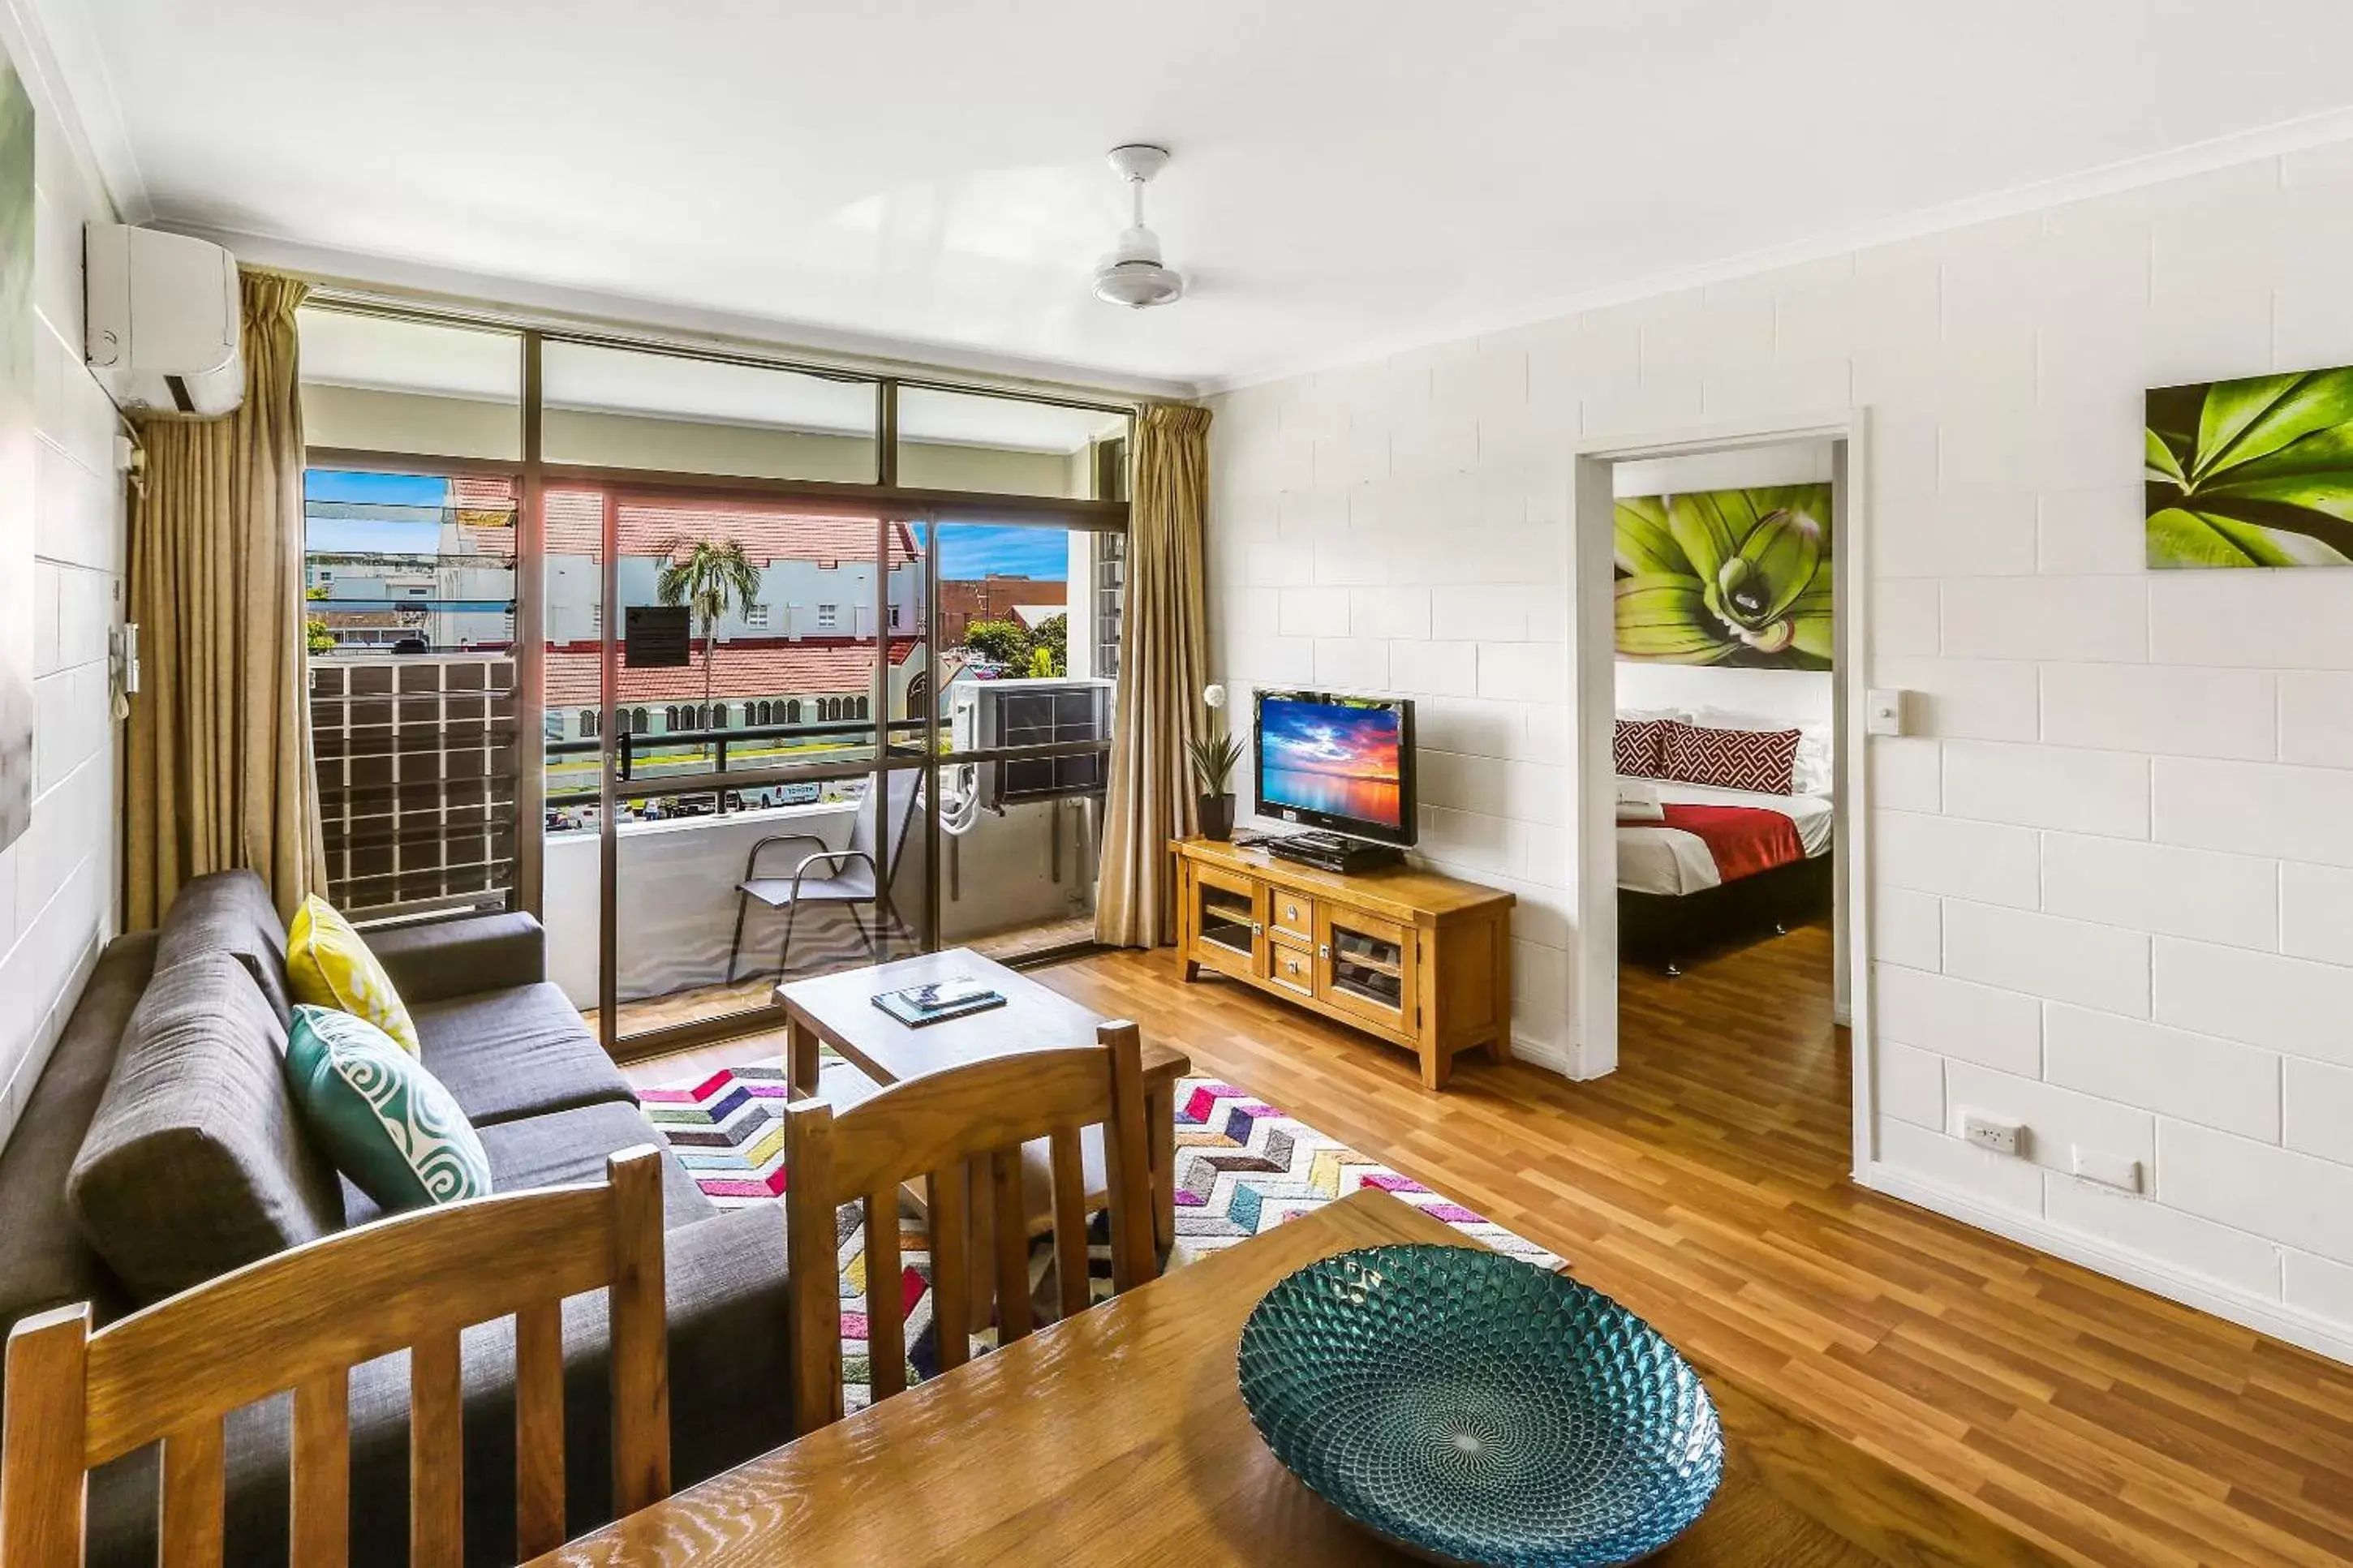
[{"left": 1616, "top": 778, "right": 1833, "bottom": 976}]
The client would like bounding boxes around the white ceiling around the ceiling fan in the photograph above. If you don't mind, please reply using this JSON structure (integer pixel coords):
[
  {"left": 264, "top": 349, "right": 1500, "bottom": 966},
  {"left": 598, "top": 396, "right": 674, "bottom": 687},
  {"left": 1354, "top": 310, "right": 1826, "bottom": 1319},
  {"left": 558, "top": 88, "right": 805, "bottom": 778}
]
[{"left": 36, "top": 0, "right": 2353, "bottom": 385}]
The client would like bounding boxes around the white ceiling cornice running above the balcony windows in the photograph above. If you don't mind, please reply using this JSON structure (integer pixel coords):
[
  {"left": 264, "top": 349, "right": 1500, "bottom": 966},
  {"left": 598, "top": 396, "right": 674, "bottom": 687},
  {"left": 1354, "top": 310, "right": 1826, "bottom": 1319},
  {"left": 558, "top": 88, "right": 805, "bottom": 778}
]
[{"left": 171, "top": 219, "right": 1198, "bottom": 402}]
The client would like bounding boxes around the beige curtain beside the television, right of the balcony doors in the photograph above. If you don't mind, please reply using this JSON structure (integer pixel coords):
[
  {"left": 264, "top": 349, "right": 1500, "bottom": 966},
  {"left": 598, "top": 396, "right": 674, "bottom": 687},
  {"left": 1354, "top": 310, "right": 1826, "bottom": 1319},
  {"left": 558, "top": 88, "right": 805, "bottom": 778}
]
[{"left": 1095, "top": 404, "right": 1210, "bottom": 947}]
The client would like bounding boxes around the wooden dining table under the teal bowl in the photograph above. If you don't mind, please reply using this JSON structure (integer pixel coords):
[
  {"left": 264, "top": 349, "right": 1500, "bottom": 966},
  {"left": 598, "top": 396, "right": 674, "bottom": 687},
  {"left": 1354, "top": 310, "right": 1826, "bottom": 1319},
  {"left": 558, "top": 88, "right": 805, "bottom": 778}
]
[{"left": 539, "top": 1192, "right": 2061, "bottom": 1568}]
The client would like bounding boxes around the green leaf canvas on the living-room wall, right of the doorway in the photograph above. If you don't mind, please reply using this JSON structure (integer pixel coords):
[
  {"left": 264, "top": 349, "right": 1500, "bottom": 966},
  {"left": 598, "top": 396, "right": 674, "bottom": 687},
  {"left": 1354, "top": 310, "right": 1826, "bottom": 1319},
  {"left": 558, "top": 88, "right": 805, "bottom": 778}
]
[{"left": 2144, "top": 369, "right": 2353, "bottom": 566}]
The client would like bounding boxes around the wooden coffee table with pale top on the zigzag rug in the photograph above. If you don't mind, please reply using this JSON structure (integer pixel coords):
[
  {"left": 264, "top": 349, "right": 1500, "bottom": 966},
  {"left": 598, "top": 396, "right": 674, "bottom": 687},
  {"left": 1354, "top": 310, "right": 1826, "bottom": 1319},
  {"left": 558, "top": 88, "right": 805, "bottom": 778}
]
[{"left": 776, "top": 947, "right": 1193, "bottom": 1312}]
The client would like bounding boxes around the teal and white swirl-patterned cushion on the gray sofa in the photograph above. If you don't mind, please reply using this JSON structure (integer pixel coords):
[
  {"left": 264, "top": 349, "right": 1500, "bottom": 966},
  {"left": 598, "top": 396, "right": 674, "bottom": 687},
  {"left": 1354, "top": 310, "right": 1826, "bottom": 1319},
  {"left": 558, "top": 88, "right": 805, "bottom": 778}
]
[{"left": 285, "top": 1006, "right": 489, "bottom": 1213}]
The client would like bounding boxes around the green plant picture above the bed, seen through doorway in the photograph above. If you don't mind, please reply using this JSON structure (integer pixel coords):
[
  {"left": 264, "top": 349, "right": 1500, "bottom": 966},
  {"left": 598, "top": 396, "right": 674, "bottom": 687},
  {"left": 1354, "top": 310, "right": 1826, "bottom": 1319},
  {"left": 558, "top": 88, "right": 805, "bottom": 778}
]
[{"left": 1616, "top": 484, "right": 1833, "bottom": 670}]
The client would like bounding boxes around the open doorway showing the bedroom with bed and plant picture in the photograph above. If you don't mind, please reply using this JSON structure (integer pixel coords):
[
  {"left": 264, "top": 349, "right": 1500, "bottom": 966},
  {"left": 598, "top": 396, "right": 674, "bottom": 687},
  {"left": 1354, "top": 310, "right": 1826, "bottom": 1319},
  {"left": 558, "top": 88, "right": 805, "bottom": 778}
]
[{"left": 1579, "top": 415, "right": 1859, "bottom": 1166}]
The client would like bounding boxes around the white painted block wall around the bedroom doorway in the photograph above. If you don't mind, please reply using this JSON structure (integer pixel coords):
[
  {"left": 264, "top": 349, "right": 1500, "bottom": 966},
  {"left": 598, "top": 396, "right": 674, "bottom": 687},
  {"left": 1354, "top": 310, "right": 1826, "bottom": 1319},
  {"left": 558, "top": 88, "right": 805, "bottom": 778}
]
[{"left": 1210, "top": 146, "right": 2353, "bottom": 1356}]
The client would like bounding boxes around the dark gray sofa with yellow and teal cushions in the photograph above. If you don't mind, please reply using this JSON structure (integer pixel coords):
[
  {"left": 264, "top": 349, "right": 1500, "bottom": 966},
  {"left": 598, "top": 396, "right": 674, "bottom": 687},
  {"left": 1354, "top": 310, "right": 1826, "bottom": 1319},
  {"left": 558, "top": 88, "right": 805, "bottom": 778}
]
[{"left": 0, "top": 872, "right": 790, "bottom": 1566}]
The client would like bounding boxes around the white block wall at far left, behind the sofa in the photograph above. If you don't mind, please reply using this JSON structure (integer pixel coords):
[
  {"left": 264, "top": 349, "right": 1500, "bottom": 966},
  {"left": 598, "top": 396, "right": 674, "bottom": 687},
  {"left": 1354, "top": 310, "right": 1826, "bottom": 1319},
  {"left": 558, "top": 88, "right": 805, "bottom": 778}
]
[{"left": 0, "top": 7, "right": 125, "bottom": 1142}]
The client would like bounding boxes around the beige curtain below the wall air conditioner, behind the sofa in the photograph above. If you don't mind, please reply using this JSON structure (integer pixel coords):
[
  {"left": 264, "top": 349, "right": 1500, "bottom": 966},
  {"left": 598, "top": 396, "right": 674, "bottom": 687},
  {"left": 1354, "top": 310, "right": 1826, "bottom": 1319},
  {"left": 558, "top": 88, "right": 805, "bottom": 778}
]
[{"left": 125, "top": 273, "right": 327, "bottom": 931}]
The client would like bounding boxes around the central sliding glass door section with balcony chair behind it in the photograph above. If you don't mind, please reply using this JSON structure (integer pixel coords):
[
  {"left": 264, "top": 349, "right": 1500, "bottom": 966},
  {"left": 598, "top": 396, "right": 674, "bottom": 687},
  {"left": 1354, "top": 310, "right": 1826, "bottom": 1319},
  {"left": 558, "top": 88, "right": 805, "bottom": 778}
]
[{"left": 544, "top": 484, "right": 925, "bottom": 1050}]
